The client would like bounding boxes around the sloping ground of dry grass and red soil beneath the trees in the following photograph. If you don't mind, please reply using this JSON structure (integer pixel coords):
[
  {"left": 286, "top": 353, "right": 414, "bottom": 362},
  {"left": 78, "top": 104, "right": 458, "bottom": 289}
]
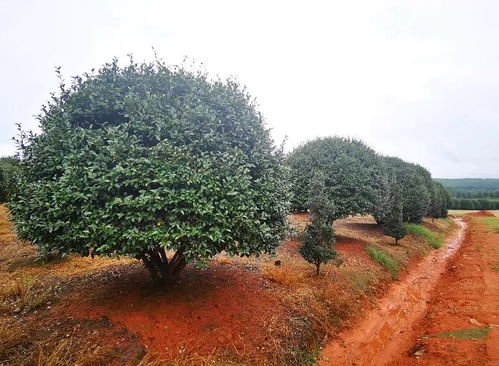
[{"left": 0, "top": 206, "right": 456, "bottom": 366}]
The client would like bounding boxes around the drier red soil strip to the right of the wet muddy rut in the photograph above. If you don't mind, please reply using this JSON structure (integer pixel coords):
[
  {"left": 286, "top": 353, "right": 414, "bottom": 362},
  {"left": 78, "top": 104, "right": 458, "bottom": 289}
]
[{"left": 393, "top": 215, "right": 499, "bottom": 366}]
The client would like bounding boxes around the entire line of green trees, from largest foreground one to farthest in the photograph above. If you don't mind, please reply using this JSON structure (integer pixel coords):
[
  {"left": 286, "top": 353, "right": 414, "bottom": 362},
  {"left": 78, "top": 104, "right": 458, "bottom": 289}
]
[{"left": 9, "top": 59, "right": 454, "bottom": 281}]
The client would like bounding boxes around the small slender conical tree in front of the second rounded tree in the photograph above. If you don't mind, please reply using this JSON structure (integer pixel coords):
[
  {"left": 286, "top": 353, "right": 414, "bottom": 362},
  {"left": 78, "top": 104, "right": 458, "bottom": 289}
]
[{"left": 300, "top": 173, "right": 338, "bottom": 275}]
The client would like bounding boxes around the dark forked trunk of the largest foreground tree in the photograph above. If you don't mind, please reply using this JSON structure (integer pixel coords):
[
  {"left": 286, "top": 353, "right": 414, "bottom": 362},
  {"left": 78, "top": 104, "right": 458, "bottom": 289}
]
[{"left": 137, "top": 246, "right": 187, "bottom": 285}]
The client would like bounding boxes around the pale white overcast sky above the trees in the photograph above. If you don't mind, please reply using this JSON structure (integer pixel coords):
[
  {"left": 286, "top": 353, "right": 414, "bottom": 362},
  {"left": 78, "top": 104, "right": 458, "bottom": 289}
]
[{"left": 0, "top": 0, "right": 499, "bottom": 178}]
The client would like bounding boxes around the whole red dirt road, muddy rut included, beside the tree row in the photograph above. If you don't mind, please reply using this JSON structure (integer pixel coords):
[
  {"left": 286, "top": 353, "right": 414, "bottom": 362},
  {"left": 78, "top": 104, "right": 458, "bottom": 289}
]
[{"left": 320, "top": 219, "right": 499, "bottom": 366}]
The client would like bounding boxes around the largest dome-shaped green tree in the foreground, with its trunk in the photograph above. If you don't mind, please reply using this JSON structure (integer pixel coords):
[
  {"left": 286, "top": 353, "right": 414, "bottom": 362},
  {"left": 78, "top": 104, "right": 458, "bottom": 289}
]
[{"left": 11, "top": 60, "right": 288, "bottom": 281}]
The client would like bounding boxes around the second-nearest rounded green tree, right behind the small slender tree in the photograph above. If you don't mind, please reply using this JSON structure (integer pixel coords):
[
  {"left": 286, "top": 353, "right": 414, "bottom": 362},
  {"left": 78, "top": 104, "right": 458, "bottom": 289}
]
[{"left": 287, "top": 136, "right": 379, "bottom": 220}]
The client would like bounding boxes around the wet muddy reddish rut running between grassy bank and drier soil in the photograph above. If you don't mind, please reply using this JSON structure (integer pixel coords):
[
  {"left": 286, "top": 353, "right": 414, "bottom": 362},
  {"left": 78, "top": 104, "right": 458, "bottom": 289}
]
[{"left": 320, "top": 220, "right": 480, "bottom": 366}]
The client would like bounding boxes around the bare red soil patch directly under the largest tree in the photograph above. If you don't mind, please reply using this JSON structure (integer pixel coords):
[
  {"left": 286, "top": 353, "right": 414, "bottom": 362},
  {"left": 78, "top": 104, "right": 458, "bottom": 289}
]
[{"left": 59, "top": 263, "right": 285, "bottom": 358}]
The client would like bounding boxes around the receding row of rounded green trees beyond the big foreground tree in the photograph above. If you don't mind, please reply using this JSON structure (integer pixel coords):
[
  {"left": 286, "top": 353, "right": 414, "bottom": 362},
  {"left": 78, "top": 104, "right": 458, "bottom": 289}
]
[{"left": 287, "top": 137, "right": 450, "bottom": 265}]
